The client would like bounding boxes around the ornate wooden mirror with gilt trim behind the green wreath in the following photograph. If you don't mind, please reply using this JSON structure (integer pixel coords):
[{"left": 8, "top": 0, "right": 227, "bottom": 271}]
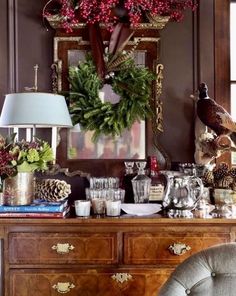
[{"left": 52, "top": 27, "right": 170, "bottom": 176}]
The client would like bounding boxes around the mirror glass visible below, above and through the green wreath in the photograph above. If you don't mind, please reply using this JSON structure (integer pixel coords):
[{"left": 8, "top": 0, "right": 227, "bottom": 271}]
[{"left": 67, "top": 49, "right": 147, "bottom": 159}]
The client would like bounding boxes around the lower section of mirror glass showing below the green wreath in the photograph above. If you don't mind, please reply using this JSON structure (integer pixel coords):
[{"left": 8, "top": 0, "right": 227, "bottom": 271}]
[{"left": 67, "top": 121, "right": 146, "bottom": 160}]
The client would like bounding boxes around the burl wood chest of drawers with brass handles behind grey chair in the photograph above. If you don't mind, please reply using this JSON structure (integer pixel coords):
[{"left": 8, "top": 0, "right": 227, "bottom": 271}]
[{"left": 0, "top": 216, "right": 236, "bottom": 296}]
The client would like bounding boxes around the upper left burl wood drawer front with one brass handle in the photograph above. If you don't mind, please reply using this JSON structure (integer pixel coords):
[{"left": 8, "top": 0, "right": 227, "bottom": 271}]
[{"left": 9, "top": 233, "right": 118, "bottom": 264}]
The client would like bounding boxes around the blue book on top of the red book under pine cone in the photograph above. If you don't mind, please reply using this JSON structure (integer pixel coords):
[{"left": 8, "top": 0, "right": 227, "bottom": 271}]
[{"left": 0, "top": 200, "right": 68, "bottom": 213}]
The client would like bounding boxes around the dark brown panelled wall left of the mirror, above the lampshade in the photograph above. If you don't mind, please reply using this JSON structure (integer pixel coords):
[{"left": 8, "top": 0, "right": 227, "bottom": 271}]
[{"left": 0, "top": 0, "right": 53, "bottom": 96}]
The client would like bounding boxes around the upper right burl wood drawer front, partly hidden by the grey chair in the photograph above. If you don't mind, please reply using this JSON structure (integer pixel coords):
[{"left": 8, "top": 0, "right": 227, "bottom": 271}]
[{"left": 124, "top": 233, "right": 230, "bottom": 265}]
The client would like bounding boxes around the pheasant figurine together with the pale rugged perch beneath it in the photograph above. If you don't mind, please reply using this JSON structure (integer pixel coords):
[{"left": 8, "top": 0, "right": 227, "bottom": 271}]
[{"left": 195, "top": 83, "right": 236, "bottom": 164}]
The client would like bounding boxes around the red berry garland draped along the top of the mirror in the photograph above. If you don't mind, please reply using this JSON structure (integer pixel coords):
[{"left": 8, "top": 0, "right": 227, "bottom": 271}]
[{"left": 43, "top": 0, "right": 198, "bottom": 32}]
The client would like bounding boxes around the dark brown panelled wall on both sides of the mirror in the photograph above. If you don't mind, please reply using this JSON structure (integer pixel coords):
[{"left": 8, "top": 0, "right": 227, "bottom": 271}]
[{"left": 0, "top": 0, "right": 218, "bottom": 171}]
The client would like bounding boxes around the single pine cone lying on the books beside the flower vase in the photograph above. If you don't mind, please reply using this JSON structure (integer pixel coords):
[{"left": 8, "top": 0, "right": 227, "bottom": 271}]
[{"left": 35, "top": 179, "right": 71, "bottom": 202}]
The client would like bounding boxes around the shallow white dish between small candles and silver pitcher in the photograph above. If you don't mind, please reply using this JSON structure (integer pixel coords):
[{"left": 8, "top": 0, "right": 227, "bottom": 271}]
[{"left": 121, "top": 203, "right": 161, "bottom": 216}]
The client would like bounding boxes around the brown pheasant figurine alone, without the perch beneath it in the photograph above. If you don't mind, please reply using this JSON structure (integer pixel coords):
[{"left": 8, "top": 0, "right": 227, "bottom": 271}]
[{"left": 197, "top": 83, "right": 236, "bottom": 144}]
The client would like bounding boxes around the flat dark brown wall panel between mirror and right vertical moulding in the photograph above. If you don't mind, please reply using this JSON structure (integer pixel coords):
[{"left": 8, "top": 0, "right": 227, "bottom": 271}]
[{"left": 160, "top": 13, "right": 194, "bottom": 162}]
